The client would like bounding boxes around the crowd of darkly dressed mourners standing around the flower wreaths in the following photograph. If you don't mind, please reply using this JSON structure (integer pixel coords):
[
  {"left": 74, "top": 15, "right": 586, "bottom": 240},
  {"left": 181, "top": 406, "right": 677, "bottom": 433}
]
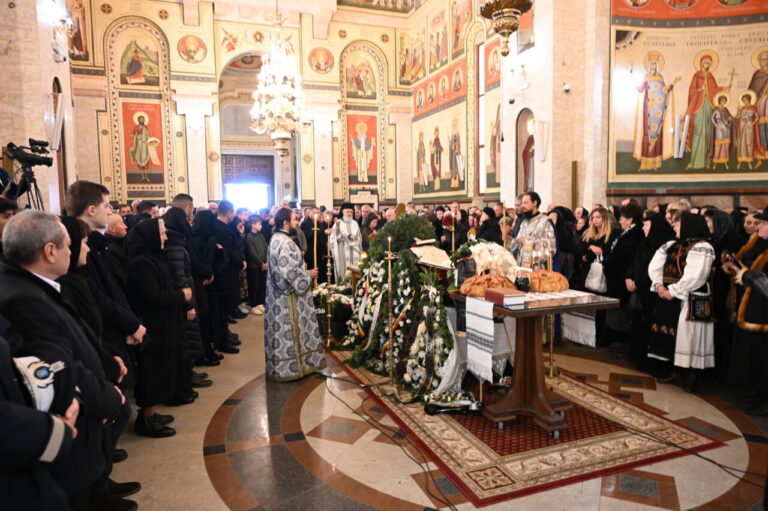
[{"left": 0, "top": 181, "right": 768, "bottom": 510}]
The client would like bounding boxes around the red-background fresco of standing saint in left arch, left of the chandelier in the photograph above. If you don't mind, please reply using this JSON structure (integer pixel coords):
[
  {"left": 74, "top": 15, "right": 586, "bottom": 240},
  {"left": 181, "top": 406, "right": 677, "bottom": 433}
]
[{"left": 120, "top": 101, "right": 165, "bottom": 184}]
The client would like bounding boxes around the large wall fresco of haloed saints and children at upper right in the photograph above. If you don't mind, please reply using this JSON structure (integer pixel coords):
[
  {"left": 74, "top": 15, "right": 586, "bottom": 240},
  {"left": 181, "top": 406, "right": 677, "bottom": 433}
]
[{"left": 609, "top": 0, "right": 768, "bottom": 186}]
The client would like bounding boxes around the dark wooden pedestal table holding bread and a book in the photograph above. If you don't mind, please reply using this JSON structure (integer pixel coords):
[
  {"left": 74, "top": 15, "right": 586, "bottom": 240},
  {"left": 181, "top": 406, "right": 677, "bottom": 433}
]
[{"left": 450, "top": 292, "right": 619, "bottom": 438}]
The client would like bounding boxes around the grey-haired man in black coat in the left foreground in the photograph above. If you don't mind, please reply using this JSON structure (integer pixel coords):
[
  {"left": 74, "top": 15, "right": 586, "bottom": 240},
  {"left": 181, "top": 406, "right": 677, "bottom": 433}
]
[{"left": 0, "top": 210, "right": 124, "bottom": 509}]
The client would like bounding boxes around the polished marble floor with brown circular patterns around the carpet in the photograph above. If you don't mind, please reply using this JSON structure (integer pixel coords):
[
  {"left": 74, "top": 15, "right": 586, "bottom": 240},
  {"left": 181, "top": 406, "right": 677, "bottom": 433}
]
[{"left": 114, "top": 317, "right": 768, "bottom": 511}]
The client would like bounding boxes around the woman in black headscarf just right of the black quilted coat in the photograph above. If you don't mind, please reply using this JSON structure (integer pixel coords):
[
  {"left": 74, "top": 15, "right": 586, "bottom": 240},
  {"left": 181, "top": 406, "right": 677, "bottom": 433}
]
[{"left": 189, "top": 210, "right": 228, "bottom": 366}]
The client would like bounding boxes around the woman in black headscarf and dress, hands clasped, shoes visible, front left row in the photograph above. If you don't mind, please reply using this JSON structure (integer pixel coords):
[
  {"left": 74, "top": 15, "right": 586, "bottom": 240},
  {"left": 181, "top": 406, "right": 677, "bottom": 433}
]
[{"left": 126, "top": 218, "right": 192, "bottom": 437}]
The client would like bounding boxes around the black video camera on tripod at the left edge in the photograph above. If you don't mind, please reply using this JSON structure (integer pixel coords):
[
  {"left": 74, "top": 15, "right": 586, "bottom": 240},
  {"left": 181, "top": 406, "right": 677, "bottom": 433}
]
[{"left": 0, "top": 138, "right": 53, "bottom": 210}]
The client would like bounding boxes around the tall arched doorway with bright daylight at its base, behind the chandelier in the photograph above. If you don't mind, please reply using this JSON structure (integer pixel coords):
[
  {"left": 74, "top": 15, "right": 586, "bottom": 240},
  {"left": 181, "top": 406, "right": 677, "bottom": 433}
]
[{"left": 219, "top": 53, "right": 280, "bottom": 211}]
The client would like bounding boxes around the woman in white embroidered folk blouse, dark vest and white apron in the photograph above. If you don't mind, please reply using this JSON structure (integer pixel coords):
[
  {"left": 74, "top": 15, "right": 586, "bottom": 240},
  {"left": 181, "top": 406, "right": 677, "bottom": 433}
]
[{"left": 648, "top": 212, "right": 715, "bottom": 392}]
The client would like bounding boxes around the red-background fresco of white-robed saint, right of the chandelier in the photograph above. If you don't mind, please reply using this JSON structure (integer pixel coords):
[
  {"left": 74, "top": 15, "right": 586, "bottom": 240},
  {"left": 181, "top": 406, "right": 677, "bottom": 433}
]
[{"left": 347, "top": 114, "right": 380, "bottom": 185}]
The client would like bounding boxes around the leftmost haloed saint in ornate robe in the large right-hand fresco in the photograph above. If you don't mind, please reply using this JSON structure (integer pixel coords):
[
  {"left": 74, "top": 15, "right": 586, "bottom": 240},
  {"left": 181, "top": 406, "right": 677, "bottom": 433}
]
[{"left": 633, "top": 51, "right": 680, "bottom": 170}]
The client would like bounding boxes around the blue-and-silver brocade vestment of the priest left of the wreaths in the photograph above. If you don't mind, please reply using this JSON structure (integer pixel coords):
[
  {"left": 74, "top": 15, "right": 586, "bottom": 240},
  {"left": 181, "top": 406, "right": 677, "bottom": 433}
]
[{"left": 264, "top": 230, "right": 325, "bottom": 382}]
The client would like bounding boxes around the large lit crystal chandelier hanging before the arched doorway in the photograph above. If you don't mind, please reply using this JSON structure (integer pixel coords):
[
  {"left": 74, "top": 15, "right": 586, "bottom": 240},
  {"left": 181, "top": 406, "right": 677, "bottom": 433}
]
[{"left": 251, "top": 5, "right": 304, "bottom": 161}]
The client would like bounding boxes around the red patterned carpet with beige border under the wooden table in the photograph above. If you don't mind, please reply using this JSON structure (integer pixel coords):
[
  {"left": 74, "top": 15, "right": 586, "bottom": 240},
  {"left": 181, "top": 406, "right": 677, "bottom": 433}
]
[{"left": 331, "top": 352, "right": 724, "bottom": 506}]
